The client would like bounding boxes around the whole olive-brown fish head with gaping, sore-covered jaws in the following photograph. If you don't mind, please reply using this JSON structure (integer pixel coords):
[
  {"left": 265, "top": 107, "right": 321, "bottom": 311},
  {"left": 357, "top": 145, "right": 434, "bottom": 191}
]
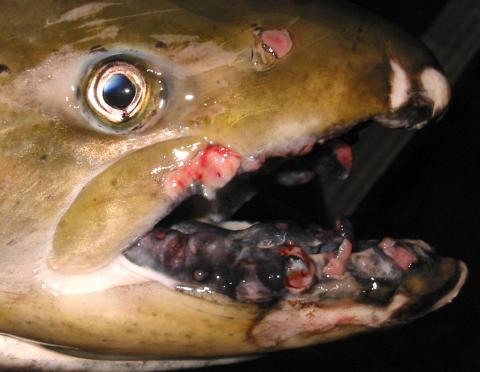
[{"left": 0, "top": 0, "right": 466, "bottom": 366}]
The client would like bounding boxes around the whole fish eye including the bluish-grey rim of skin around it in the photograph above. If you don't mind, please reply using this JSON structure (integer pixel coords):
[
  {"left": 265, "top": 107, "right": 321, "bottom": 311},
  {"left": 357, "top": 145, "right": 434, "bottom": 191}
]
[{"left": 81, "top": 50, "right": 174, "bottom": 136}]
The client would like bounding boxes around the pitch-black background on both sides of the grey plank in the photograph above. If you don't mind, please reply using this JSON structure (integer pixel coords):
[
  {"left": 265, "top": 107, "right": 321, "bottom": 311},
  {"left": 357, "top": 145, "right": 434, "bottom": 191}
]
[{"left": 193, "top": 0, "right": 480, "bottom": 372}]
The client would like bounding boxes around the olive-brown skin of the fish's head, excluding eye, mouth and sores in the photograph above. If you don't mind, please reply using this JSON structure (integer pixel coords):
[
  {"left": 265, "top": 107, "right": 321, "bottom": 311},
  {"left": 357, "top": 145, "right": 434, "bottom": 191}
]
[{"left": 0, "top": 0, "right": 450, "bottom": 357}]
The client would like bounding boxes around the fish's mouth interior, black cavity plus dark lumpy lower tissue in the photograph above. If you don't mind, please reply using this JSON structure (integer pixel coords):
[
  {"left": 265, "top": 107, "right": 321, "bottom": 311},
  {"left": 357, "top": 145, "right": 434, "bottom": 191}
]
[{"left": 124, "top": 137, "right": 462, "bottom": 306}]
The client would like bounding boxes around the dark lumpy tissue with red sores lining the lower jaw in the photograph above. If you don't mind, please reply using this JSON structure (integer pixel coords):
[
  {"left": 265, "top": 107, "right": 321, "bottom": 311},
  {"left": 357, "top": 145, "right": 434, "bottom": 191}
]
[{"left": 124, "top": 215, "right": 464, "bottom": 306}]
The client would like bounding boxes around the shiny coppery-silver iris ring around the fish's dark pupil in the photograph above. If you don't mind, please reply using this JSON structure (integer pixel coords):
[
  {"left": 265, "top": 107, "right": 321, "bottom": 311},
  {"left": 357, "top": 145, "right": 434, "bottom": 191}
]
[{"left": 86, "top": 61, "right": 149, "bottom": 124}]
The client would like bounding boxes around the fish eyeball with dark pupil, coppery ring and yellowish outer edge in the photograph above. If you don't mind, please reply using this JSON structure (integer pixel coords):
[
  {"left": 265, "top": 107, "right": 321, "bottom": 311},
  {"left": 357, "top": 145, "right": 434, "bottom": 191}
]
[{"left": 84, "top": 55, "right": 167, "bottom": 134}]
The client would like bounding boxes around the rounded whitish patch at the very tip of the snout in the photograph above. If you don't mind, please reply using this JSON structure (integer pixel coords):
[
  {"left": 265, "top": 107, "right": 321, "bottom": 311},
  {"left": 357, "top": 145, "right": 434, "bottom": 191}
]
[{"left": 420, "top": 67, "right": 450, "bottom": 116}]
